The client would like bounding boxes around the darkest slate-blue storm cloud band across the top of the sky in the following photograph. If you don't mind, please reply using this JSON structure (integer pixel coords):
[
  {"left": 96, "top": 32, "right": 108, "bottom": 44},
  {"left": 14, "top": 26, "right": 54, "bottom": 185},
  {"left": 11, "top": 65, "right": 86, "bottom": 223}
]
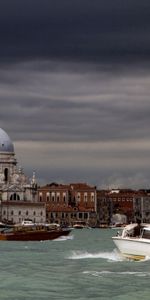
[{"left": 0, "top": 0, "right": 150, "bottom": 62}]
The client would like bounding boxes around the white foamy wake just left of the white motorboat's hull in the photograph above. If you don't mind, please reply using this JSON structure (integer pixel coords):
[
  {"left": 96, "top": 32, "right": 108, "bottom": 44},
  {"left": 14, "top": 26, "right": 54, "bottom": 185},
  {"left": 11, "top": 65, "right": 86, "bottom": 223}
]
[{"left": 68, "top": 250, "right": 124, "bottom": 261}]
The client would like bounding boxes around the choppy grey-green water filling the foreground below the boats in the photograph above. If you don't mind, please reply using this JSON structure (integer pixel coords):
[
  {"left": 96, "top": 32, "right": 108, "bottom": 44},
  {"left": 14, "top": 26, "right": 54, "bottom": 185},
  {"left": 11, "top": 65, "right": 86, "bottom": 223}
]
[{"left": 0, "top": 229, "right": 150, "bottom": 300}]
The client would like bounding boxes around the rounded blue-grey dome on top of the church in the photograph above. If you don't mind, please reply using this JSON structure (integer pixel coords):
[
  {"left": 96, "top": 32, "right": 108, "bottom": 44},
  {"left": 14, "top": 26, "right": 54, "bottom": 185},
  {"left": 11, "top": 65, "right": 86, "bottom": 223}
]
[{"left": 0, "top": 128, "right": 14, "bottom": 152}]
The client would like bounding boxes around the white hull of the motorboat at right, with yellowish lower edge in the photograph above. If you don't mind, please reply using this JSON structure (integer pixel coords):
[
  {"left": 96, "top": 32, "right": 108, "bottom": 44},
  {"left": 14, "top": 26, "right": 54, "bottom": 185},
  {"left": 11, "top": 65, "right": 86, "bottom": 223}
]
[{"left": 112, "top": 236, "right": 150, "bottom": 260}]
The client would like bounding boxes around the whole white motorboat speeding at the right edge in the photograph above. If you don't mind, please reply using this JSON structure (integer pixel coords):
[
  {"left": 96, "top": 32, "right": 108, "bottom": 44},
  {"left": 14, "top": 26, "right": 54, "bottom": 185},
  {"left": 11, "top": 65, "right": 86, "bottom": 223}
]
[{"left": 112, "top": 223, "right": 150, "bottom": 260}]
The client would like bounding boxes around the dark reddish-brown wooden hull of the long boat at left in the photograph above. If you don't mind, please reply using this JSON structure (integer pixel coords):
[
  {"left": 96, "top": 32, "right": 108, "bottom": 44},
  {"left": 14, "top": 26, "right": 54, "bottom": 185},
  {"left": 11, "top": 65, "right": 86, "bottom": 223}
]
[{"left": 0, "top": 230, "right": 70, "bottom": 241}]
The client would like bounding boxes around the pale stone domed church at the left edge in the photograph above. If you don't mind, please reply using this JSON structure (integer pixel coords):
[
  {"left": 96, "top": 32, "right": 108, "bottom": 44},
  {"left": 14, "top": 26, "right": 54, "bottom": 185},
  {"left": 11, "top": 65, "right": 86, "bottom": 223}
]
[{"left": 0, "top": 128, "right": 46, "bottom": 223}]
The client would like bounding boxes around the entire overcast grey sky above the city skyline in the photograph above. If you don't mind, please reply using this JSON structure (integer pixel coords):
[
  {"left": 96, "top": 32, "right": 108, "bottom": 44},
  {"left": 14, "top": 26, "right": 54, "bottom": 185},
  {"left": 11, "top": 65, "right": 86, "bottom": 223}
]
[{"left": 0, "top": 0, "right": 150, "bottom": 189}]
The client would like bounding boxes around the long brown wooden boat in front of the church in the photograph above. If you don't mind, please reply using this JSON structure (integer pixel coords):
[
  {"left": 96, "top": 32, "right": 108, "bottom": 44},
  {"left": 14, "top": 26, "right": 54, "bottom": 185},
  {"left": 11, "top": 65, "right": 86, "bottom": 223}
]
[{"left": 0, "top": 223, "right": 71, "bottom": 241}]
